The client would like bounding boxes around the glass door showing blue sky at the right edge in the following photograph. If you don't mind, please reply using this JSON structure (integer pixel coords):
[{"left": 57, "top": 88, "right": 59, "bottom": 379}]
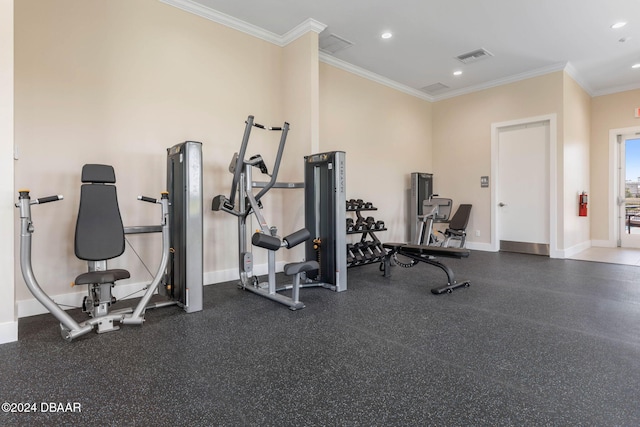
[{"left": 618, "top": 134, "right": 640, "bottom": 248}]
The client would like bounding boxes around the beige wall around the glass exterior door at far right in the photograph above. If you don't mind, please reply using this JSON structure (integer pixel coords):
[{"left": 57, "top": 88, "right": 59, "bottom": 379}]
[{"left": 589, "top": 89, "right": 640, "bottom": 244}]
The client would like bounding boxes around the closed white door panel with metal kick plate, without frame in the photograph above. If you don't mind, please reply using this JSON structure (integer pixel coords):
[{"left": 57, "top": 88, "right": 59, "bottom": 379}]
[{"left": 496, "top": 121, "right": 550, "bottom": 255}]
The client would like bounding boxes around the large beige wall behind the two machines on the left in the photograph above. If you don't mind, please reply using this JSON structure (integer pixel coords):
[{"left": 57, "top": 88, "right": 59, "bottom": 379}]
[{"left": 15, "top": 0, "right": 286, "bottom": 300}]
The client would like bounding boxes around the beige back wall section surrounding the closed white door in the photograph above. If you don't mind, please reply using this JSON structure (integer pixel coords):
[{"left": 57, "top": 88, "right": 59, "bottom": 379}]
[{"left": 433, "top": 72, "right": 564, "bottom": 247}]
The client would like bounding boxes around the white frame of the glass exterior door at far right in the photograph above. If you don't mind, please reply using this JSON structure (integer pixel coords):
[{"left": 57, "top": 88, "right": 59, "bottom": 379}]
[{"left": 599, "top": 126, "right": 640, "bottom": 248}]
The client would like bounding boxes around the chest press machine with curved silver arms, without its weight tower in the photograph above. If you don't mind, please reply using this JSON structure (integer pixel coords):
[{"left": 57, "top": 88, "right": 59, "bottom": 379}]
[{"left": 16, "top": 164, "right": 202, "bottom": 341}]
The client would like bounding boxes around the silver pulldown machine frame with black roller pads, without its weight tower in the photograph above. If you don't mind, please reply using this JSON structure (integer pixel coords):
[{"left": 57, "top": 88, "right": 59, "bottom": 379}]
[{"left": 211, "top": 116, "right": 319, "bottom": 310}]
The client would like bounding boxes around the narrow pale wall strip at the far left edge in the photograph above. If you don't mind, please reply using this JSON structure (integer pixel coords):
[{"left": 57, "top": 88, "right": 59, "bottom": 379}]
[{"left": 0, "top": 0, "right": 20, "bottom": 344}]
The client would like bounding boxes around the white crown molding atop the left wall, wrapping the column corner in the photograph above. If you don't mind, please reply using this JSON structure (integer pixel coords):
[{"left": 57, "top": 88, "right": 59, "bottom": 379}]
[{"left": 159, "top": 0, "right": 327, "bottom": 47}]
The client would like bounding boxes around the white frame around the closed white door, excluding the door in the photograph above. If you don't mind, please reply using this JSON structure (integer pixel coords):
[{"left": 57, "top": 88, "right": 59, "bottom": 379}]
[{"left": 491, "top": 114, "right": 564, "bottom": 258}]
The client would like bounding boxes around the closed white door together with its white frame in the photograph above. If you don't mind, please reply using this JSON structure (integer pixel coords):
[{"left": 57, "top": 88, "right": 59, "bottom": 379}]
[{"left": 491, "top": 115, "right": 558, "bottom": 257}]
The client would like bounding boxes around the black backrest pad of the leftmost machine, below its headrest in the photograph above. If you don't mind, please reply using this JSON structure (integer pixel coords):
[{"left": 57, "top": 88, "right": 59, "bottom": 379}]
[{"left": 75, "top": 181, "right": 124, "bottom": 261}]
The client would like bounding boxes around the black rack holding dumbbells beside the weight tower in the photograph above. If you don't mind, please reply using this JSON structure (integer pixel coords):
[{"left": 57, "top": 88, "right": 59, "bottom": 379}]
[{"left": 346, "top": 199, "right": 387, "bottom": 267}]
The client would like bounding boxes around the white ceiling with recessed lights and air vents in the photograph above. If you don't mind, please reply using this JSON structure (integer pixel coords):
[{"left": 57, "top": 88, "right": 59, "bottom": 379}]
[{"left": 174, "top": 0, "right": 640, "bottom": 100}]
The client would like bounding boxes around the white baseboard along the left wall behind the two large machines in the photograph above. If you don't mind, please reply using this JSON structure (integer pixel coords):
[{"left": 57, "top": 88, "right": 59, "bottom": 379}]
[{"left": 16, "top": 261, "right": 285, "bottom": 320}]
